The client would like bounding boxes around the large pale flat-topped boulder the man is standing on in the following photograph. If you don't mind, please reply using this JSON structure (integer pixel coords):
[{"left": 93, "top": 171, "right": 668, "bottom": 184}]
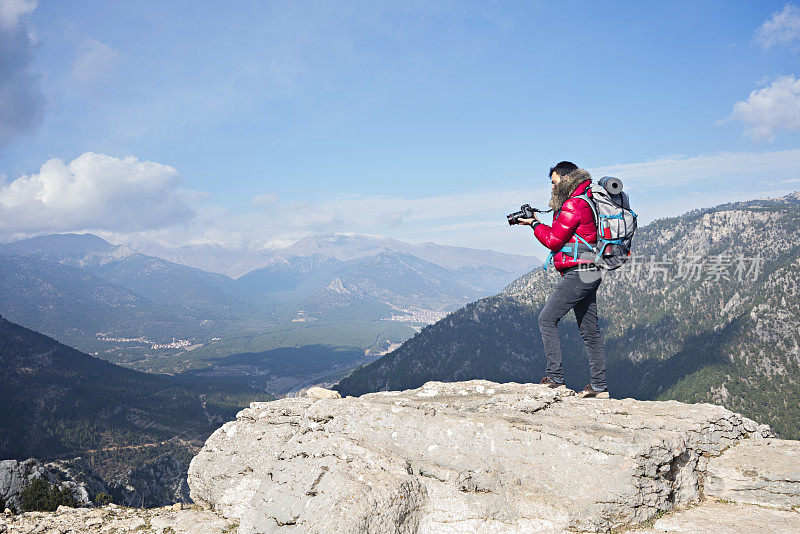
[{"left": 184, "top": 380, "right": 800, "bottom": 534}]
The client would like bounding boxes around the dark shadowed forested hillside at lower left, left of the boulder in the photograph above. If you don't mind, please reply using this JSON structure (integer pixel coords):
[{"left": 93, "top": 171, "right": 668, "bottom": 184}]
[{"left": 0, "top": 317, "right": 271, "bottom": 459}]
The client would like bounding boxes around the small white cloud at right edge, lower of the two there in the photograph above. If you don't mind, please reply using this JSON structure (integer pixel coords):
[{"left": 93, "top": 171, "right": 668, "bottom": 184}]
[{"left": 722, "top": 76, "right": 800, "bottom": 141}]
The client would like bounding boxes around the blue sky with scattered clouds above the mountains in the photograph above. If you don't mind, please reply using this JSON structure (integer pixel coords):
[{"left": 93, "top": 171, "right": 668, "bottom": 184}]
[{"left": 0, "top": 0, "right": 800, "bottom": 257}]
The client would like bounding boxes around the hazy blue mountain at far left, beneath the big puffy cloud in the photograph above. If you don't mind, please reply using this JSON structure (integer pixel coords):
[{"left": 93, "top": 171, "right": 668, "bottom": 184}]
[{"left": 0, "top": 234, "right": 273, "bottom": 368}]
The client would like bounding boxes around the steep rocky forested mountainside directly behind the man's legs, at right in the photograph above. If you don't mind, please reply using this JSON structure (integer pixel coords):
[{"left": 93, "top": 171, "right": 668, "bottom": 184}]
[{"left": 337, "top": 193, "right": 800, "bottom": 438}]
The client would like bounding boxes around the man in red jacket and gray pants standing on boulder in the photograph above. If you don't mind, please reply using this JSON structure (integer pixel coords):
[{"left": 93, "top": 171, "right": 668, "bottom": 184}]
[{"left": 519, "top": 161, "right": 609, "bottom": 399}]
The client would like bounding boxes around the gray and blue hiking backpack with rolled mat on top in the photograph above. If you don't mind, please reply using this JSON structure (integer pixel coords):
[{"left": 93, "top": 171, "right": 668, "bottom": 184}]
[{"left": 545, "top": 176, "right": 637, "bottom": 271}]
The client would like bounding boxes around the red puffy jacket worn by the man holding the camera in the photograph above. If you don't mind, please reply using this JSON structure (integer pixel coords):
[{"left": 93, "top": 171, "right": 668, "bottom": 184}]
[{"left": 533, "top": 180, "right": 597, "bottom": 276}]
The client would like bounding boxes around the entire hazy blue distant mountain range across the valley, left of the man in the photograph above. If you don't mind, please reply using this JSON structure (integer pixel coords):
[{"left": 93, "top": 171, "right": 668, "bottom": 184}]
[{"left": 0, "top": 234, "right": 538, "bottom": 378}]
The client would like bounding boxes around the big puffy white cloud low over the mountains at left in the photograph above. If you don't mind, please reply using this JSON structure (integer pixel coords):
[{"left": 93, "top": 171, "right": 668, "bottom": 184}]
[{"left": 0, "top": 152, "right": 193, "bottom": 239}]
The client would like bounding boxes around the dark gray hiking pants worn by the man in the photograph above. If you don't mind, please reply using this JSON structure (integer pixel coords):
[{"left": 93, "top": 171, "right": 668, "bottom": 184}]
[{"left": 539, "top": 270, "right": 607, "bottom": 390}]
